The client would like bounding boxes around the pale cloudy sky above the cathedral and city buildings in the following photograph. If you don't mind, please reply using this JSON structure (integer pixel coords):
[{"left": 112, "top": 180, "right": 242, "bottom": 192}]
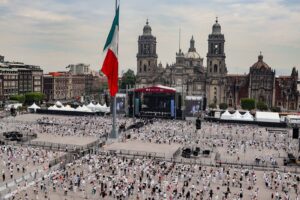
[{"left": 0, "top": 0, "right": 300, "bottom": 75}]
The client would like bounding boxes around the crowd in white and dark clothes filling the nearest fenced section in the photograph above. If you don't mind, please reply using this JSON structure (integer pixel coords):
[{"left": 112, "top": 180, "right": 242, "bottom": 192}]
[{"left": 7, "top": 153, "right": 300, "bottom": 200}]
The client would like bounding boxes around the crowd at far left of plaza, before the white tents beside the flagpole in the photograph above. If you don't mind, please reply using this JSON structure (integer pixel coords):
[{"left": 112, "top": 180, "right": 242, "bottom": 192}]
[{"left": 0, "top": 116, "right": 131, "bottom": 138}]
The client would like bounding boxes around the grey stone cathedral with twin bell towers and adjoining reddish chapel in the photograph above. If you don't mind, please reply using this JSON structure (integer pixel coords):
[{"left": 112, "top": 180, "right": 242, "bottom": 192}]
[{"left": 136, "top": 19, "right": 300, "bottom": 110}]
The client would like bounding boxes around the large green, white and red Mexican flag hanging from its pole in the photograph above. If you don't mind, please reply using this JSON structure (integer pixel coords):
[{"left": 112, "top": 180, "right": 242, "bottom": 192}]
[{"left": 101, "top": 6, "right": 119, "bottom": 97}]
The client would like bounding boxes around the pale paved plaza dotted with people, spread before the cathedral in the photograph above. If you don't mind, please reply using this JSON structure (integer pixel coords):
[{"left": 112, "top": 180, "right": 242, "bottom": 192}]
[{"left": 0, "top": 114, "right": 300, "bottom": 200}]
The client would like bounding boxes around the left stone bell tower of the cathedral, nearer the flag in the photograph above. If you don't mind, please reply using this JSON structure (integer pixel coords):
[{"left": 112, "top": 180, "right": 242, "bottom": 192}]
[{"left": 136, "top": 20, "right": 157, "bottom": 87}]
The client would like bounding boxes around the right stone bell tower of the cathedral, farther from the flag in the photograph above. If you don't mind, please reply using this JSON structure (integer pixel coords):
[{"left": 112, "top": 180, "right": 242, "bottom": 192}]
[{"left": 206, "top": 18, "right": 227, "bottom": 105}]
